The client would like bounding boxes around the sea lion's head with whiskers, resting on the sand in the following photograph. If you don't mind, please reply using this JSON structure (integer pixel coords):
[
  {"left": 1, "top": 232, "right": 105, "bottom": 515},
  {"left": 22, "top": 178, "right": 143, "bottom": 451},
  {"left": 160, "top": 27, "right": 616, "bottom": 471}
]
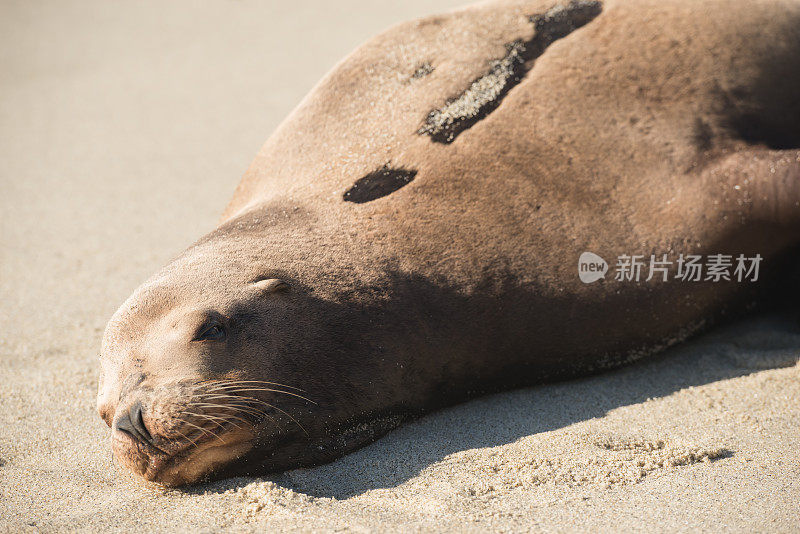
[{"left": 97, "top": 232, "right": 362, "bottom": 486}]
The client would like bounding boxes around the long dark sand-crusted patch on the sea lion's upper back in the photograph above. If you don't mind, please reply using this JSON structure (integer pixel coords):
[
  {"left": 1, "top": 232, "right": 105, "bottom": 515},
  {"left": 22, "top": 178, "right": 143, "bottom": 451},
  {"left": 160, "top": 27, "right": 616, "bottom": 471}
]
[{"left": 417, "top": 0, "right": 602, "bottom": 143}]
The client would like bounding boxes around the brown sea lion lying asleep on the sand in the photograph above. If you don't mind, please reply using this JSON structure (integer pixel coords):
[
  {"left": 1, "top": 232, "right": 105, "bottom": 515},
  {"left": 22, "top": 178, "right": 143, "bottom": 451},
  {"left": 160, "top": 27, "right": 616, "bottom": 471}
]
[{"left": 98, "top": 0, "right": 800, "bottom": 485}]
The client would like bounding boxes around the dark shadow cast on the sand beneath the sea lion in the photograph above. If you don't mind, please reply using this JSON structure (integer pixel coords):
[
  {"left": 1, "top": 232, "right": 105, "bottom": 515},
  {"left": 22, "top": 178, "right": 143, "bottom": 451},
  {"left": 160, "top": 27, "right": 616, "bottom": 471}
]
[{"left": 272, "top": 311, "right": 800, "bottom": 499}]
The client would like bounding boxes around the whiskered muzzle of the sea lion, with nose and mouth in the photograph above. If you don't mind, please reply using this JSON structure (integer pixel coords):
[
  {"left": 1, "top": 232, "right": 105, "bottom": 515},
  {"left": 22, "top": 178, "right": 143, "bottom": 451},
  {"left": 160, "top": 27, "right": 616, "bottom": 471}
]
[{"left": 111, "top": 380, "right": 313, "bottom": 486}]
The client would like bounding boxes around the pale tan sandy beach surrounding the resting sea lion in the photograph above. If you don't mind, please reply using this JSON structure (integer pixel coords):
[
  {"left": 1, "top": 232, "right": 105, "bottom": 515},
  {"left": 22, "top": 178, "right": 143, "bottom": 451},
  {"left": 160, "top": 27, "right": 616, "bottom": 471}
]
[{"left": 0, "top": 0, "right": 800, "bottom": 532}]
